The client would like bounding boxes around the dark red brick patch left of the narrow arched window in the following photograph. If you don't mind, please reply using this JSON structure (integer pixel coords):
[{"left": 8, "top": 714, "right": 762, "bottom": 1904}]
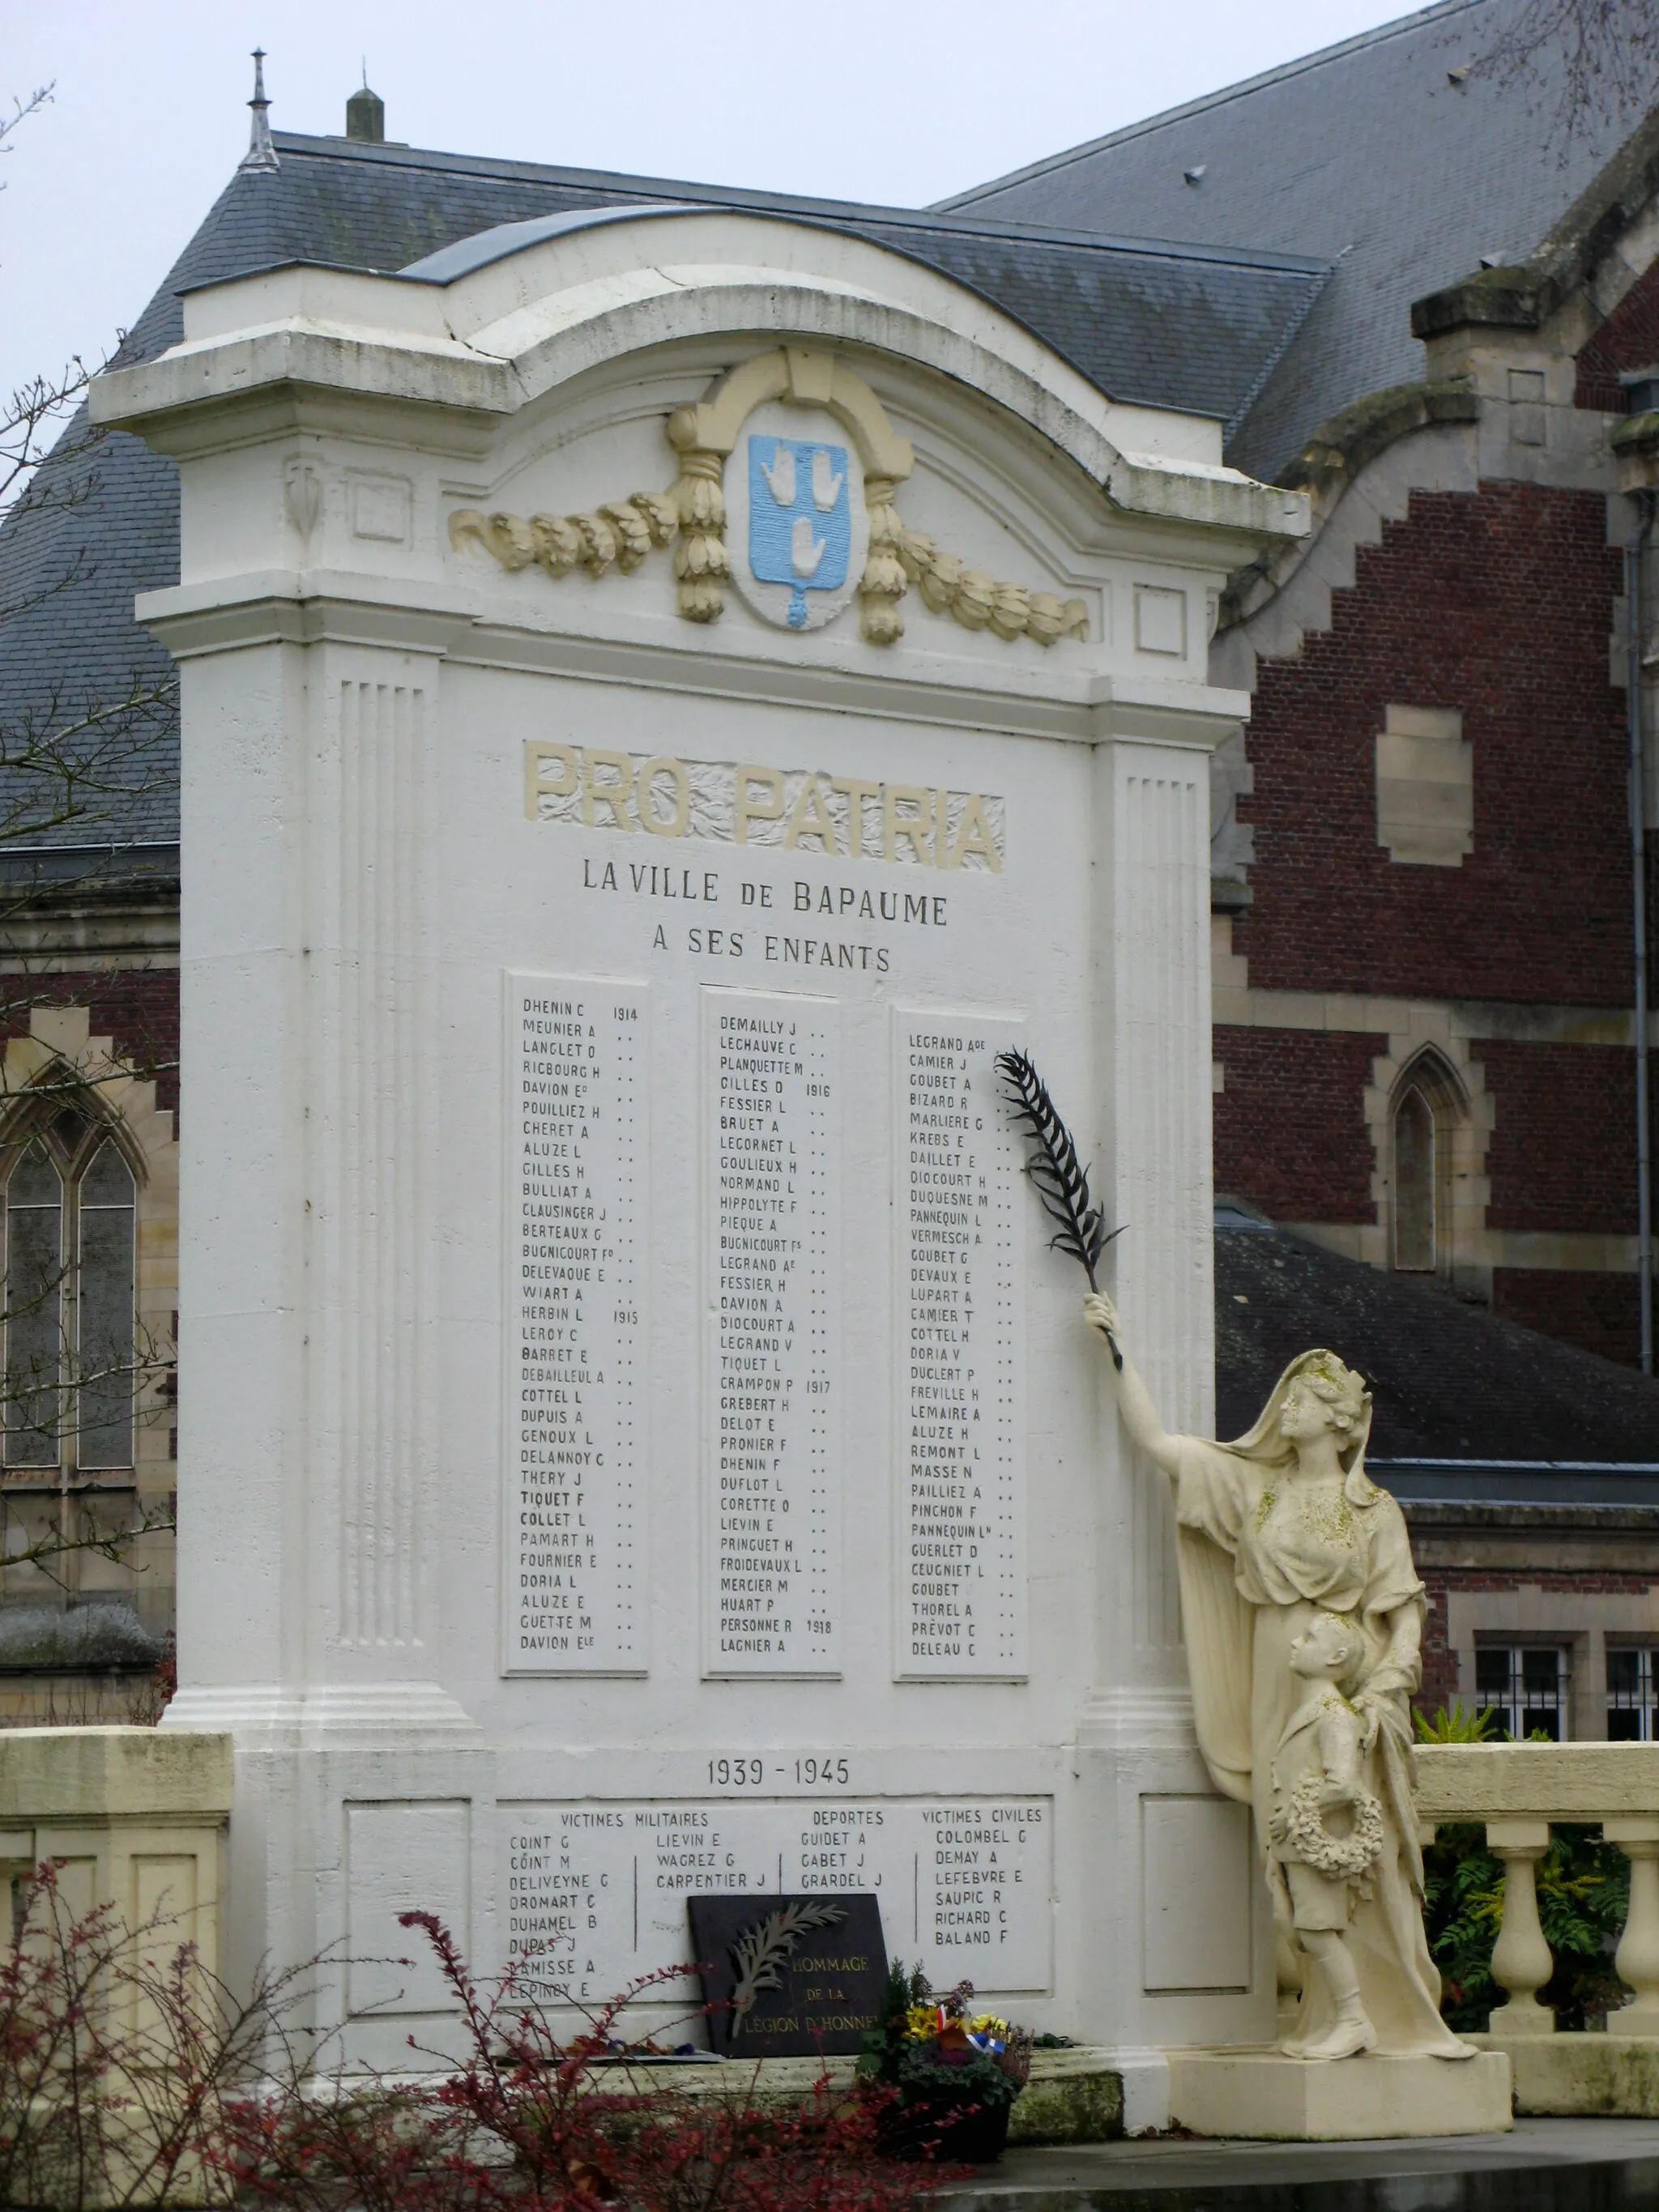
[{"left": 1214, "top": 1026, "right": 1389, "bottom": 1221}]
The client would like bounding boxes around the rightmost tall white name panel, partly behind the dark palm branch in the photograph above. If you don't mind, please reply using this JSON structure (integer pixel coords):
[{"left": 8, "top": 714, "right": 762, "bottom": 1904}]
[{"left": 893, "top": 1008, "right": 1030, "bottom": 1679}]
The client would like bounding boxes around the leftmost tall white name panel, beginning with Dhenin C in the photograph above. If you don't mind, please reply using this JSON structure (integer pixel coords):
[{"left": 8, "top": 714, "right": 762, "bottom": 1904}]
[{"left": 502, "top": 975, "right": 650, "bottom": 1674}]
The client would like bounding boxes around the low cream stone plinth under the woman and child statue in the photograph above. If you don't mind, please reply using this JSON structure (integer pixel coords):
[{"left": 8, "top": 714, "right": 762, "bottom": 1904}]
[{"left": 1171, "top": 2037, "right": 1521, "bottom": 2143}]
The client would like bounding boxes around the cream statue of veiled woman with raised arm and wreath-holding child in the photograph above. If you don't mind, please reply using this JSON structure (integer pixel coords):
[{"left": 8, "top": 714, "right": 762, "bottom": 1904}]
[{"left": 1084, "top": 1294, "right": 1475, "bottom": 2060}]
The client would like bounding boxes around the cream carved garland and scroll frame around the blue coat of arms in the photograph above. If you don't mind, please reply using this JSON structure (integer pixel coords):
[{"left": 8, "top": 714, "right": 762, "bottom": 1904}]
[{"left": 449, "top": 349, "right": 1088, "bottom": 646}]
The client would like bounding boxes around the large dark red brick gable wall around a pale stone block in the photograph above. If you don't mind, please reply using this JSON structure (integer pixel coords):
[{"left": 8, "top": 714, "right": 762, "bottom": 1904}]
[{"left": 1235, "top": 484, "right": 1631, "bottom": 1004}]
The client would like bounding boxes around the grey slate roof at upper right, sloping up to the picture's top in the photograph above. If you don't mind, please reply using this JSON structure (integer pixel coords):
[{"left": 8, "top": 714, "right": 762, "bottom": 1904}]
[{"left": 940, "top": 0, "right": 1631, "bottom": 478}]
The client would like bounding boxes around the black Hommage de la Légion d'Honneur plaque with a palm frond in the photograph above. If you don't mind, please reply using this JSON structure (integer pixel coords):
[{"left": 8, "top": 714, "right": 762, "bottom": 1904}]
[{"left": 686, "top": 1891, "right": 887, "bottom": 2060}]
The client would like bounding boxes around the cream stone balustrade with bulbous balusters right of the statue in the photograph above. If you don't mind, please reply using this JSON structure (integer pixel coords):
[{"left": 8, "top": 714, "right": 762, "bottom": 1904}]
[{"left": 1418, "top": 1743, "right": 1659, "bottom": 2115}]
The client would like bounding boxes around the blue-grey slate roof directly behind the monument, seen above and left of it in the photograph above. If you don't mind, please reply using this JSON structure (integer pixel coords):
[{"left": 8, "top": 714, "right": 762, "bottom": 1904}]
[{"left": 0, "top": 133, "right": 1327, "bottom": 874}]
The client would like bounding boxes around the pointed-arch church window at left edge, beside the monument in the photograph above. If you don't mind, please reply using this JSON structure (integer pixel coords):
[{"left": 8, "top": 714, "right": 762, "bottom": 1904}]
[{"left": 0, "top": 1110, "right": 137, "bottom": 1473}]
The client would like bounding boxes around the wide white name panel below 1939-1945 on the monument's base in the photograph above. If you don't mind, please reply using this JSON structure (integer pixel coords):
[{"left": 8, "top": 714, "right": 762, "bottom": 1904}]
[{"left": 502, "top": 1796, "right": 1053, "bottom": 2004}]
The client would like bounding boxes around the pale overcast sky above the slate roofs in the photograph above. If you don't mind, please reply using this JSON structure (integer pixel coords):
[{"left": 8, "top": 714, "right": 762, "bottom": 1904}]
[{"left": 0, "top": 0, "right": 1402, "bottom": 413}]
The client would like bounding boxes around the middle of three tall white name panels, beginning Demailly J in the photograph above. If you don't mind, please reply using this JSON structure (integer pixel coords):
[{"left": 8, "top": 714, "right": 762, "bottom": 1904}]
[{"left": 703, "top": 989, "right": 841, "bottom": 1674}]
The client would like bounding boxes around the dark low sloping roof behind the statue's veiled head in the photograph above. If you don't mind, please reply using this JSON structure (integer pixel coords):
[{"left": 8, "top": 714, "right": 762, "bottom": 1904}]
[{"left": 1214, "top": 1214, "right": 1659, "bottom": 1500}]
